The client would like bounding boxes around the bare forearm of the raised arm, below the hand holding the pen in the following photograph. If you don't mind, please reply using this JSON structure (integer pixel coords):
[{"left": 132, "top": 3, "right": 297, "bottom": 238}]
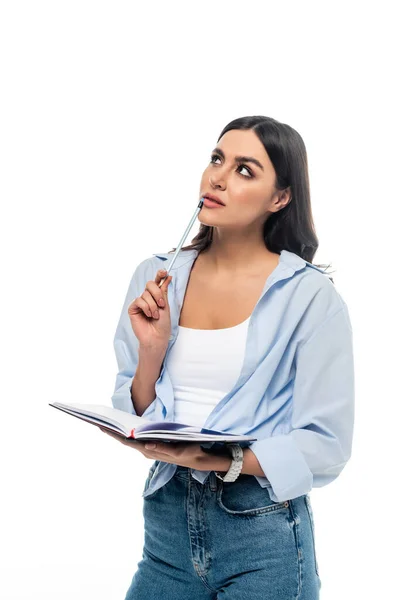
[{"left": 131, "top": 348, "right": 165, "bottom": 417}]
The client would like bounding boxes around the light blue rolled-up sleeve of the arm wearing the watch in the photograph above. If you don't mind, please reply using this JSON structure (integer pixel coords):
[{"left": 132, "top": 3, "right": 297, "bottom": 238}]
[{"left": 250, "top": 303, "right": 355, "bottom": 502}]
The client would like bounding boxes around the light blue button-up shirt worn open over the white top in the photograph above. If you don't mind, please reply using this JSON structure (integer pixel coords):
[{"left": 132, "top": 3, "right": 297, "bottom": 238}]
[{"left": 112, "top": 250, "right": 354, "bottom": 502}]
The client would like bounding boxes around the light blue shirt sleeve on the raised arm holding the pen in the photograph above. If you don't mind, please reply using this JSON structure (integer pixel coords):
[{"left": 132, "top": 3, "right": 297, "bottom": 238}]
[{"left": 111, "top": 259, "right": 157, "bottom": 419}]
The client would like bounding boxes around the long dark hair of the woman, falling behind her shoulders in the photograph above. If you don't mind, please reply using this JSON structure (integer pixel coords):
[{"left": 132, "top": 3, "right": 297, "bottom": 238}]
[{"left": 169, "top": 116, "right": 334, "bottom": 283}]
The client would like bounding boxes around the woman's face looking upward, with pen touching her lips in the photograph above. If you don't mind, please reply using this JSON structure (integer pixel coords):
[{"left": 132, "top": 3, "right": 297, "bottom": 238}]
[{"left": 198, "top": 129, "right": 290, "bottom": 228}]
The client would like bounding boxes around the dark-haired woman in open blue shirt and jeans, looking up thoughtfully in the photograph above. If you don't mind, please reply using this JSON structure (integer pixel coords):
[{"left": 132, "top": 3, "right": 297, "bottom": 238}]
[{"left": 103, "top": 116, "right": 354, "bottom": 600}]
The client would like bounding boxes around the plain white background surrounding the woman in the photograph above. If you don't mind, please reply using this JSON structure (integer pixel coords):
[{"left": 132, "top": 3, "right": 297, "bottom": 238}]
[{"left": 0, "top": 0, "right": 400, "bottom": 600}]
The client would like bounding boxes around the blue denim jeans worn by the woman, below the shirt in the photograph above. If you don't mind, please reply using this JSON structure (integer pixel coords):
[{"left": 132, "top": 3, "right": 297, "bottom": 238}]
[{"left": 125, "top": 461, "right": 321, "bottom": 600}]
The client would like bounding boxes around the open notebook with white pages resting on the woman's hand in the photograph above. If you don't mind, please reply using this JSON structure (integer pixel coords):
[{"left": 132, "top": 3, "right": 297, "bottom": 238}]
[{"left": 49, "top": 402, "right": 257, "bottom": 443}]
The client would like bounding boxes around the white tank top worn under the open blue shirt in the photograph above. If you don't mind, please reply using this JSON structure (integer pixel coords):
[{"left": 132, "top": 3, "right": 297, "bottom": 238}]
[{"left": 167, "top": 317, "right": 250, "bottom": 427}]
